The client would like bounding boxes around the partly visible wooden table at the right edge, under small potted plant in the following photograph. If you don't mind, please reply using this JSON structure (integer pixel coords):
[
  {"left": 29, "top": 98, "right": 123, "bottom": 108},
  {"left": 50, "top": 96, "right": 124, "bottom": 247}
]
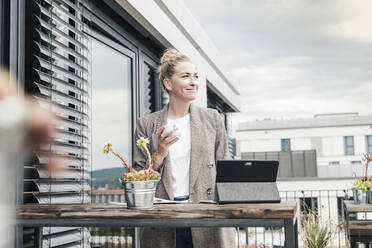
[{"left": 344, "top": 201, "right": 372, "bottom": 247}]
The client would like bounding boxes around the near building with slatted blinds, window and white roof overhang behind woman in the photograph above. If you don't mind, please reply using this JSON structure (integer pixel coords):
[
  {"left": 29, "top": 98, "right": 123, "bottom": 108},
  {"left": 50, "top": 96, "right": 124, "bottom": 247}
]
[{"left": 0, "top": 0, "right": 239, "bottom": 247}]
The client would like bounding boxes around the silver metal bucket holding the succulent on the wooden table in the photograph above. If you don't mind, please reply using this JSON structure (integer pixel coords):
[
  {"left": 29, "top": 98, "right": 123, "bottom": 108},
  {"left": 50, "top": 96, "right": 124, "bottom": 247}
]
[{"left": 122, "top": 180, "right": 160, "bottom": 209}]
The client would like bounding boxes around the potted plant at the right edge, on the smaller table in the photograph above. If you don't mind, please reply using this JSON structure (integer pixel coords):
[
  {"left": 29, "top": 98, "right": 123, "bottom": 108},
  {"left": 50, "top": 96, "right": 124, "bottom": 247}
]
[{"left": 352, "top": 154, "right": 372, "bottom": 204}]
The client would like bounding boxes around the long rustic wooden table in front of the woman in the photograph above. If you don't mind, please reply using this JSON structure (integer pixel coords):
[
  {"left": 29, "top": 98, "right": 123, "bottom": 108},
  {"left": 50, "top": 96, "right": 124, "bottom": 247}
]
[{"left": 17, "top": 202, "right": 298, "bottom": 248}]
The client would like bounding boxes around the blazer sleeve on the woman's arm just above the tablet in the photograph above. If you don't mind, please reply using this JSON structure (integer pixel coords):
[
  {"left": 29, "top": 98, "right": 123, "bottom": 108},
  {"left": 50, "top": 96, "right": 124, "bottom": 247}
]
[{"left": 214, "top": 111, "right": 231, "bottom": 161}]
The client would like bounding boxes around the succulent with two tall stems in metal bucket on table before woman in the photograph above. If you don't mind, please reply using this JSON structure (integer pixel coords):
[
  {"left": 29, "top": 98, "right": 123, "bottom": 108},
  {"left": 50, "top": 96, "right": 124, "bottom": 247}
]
[{"left": 103, "top": 137, "right": 160, "bottom": 209}]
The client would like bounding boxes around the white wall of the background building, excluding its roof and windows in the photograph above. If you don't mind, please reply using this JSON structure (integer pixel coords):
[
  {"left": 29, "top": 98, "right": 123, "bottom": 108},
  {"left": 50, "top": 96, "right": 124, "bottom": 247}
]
[{"left": 236, "top": 120, "right": 372, "bottom": 177}]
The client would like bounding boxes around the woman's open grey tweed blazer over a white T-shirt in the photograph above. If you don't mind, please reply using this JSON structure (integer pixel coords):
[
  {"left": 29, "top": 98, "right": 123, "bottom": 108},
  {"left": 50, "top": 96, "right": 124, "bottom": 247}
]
[{"left": 133, "top": 104, "right": 236, "bottom": 248}]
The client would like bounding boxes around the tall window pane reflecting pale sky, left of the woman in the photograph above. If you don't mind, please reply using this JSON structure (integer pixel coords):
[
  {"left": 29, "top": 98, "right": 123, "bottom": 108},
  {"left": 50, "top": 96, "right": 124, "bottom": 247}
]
[{"left": 91, "top": 39, "right": 132, "bottom": 170}]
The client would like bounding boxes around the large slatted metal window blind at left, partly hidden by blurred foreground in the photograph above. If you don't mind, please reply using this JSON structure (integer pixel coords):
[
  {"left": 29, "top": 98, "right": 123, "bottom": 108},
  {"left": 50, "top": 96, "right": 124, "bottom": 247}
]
[{"left": 24, "top": 0, "right": 90, "bottom": 247}]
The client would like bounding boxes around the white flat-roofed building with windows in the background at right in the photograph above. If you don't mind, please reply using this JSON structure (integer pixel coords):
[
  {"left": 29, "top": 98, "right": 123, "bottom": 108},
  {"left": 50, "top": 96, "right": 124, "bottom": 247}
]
[{"left": 237, "top": 113, "right": 372, "bottom": 178}]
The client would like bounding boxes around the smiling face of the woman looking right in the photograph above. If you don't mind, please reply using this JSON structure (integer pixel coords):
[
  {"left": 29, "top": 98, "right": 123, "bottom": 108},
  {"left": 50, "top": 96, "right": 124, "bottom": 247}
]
[{"left": 163, "top": 61, "right": 199, "bottom": 101}]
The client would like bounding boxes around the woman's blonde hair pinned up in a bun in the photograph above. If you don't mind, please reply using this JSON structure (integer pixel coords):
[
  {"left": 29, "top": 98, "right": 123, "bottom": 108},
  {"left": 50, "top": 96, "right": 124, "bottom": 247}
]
[{"left": 158, "top": 48, "right": 191, "bottom": 85}]
